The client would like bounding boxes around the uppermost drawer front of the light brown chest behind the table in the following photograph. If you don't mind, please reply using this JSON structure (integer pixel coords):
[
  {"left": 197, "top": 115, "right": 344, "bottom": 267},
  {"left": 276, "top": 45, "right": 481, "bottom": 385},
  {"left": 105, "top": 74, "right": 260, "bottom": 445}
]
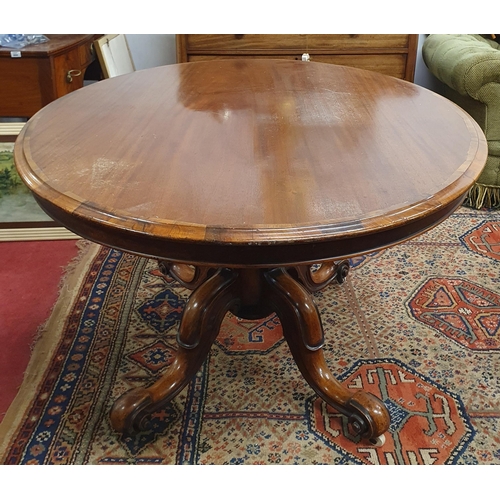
[{"left": 186, "top": 35, "right": 409, "bottom": 53}]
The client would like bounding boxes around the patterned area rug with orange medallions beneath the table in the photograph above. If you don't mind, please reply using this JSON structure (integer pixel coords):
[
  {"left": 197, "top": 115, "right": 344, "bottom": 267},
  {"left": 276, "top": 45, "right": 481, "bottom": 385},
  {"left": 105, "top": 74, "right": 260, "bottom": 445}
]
[{"left": 0, "top": 208, "right": 500, "bottom": 464}]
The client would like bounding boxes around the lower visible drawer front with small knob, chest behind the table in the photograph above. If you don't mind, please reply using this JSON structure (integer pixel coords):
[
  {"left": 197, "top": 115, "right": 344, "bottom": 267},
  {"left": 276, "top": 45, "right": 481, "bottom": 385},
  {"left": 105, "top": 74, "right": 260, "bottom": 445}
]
[{"left": 189, "top": 54, "right": 406, "bottom": 78}]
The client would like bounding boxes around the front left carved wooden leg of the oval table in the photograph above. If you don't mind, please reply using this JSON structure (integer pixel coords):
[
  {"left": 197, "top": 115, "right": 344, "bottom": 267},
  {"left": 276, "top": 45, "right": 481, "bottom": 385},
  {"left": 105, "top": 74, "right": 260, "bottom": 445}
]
[{"left": 110, "top": 269, "right": 238, "bottom": 434}]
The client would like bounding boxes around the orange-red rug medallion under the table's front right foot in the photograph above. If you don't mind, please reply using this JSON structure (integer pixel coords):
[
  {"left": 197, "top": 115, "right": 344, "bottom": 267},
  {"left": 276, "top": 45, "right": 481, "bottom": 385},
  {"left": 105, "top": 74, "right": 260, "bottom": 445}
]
[{"left": 308, "top": 359, "right": 474, "bottom": 465}]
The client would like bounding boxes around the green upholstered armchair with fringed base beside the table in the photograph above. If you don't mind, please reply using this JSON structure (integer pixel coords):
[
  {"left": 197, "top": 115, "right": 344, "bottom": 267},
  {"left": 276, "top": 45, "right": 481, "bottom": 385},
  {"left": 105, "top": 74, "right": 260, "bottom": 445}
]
[{"left": 422, "top": 35, "right": 500, "bottom": 208}]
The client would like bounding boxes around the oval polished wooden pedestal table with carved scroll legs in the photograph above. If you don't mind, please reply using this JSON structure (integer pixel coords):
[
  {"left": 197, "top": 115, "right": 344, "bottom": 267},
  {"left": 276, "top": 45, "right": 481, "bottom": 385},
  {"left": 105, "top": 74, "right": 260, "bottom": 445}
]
[{"left": 14, "top": 60, "right": 487, "bottom": 443}]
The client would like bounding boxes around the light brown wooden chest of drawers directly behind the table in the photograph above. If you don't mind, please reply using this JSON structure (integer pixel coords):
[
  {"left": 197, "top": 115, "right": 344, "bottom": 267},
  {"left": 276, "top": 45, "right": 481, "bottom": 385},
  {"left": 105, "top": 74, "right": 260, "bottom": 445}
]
[{"left": 176, "top": 35, "right": 418, "bottom": 82}]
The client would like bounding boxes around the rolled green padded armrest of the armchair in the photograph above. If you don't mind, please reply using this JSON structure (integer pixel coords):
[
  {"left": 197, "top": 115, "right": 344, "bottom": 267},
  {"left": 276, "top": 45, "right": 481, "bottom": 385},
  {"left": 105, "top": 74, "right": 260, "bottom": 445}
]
[{"left": 422, "top": 35, "right": 500, "bottom": 100}]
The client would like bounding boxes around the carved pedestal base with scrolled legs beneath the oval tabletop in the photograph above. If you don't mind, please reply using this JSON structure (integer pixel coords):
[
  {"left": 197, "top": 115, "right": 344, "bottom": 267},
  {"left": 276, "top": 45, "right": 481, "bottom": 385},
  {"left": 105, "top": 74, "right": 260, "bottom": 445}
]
[{"left": 111, "top": 264, "right": 390, "bottom": 438}]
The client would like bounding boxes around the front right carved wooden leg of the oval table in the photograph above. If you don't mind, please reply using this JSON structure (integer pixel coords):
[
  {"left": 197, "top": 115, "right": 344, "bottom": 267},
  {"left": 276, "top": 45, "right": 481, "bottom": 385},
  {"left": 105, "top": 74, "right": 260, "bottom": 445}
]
[{"left": 266, "top": 269, "right": 390, "bottom": 438}]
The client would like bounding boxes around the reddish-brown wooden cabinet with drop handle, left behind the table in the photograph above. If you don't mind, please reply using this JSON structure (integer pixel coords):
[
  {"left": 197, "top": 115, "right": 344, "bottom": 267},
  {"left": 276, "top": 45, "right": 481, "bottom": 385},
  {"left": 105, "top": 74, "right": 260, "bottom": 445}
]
[{"left": 0, "top": 35, "right": 96, "bottom": 118}]
